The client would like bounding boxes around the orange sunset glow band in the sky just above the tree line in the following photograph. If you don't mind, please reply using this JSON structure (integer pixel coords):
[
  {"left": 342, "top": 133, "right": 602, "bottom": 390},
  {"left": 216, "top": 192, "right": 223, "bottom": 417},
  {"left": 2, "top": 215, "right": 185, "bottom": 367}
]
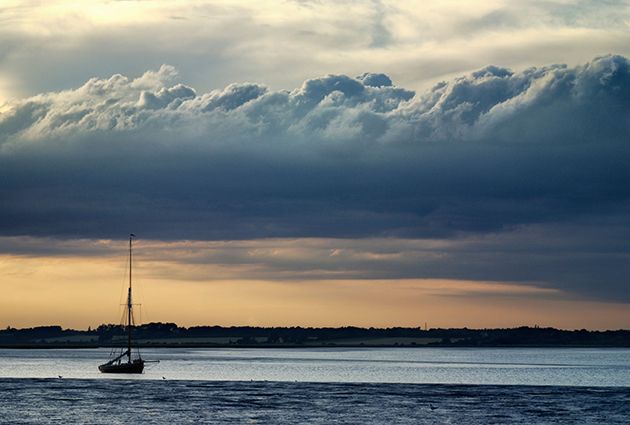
[{"left": 0, "top": 241, "right": 630, "bottom": 329}]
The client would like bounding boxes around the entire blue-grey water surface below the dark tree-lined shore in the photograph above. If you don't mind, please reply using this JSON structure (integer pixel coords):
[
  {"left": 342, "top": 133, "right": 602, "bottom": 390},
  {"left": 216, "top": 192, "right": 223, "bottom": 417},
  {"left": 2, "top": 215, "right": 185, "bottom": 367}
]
[{"left": 0, "top": 348, "right": 630, "bottom": 425}]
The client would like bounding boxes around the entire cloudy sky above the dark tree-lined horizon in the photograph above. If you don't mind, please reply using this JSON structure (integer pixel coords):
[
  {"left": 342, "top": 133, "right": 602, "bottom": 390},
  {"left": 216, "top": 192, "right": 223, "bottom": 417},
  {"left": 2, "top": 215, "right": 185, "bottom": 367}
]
[{"left": 0, "top": 0, "right": 630, "bottom": 329}]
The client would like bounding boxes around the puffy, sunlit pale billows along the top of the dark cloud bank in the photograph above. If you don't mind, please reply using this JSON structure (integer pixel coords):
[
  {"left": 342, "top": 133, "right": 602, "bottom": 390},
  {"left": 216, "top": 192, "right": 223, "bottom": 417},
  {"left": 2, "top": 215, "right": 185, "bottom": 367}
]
[{"left": 0, "top": 56, "right": 630, "bottom": 149}]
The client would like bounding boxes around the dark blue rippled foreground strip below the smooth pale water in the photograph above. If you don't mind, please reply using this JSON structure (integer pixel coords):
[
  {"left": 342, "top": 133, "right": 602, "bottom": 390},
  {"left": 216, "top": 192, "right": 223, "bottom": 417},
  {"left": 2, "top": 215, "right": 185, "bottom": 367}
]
[{"left": 0, "top": 379, "right": 630, "bottom": 425}]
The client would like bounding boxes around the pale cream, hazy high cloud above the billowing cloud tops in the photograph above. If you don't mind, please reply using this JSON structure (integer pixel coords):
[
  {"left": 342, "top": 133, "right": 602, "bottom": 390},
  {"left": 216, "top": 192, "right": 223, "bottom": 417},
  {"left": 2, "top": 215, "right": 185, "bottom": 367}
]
[{"left": 0, "top": 0, "right": 630, "bottom": 100}]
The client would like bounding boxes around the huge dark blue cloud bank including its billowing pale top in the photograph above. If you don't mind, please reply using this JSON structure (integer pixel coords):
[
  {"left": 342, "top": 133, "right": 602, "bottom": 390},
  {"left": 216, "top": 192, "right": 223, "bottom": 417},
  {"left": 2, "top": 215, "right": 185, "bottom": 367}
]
[{"left": 0, "top": 56, "right": 630, "bottom": 301}]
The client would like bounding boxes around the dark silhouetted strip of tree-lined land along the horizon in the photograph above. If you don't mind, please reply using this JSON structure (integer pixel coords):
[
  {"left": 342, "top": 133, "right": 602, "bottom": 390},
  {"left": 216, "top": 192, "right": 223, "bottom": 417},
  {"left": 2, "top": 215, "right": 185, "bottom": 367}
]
[{"left": 0, "top": 323, "right": 630, "bottom": 347}]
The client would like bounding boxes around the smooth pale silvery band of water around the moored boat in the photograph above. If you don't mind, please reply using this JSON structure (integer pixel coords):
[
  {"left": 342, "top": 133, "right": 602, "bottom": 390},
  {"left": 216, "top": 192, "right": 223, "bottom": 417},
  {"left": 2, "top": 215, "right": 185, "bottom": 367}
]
[{"left": 0, "top": 348, "right": 630, "bottom": 387}]
